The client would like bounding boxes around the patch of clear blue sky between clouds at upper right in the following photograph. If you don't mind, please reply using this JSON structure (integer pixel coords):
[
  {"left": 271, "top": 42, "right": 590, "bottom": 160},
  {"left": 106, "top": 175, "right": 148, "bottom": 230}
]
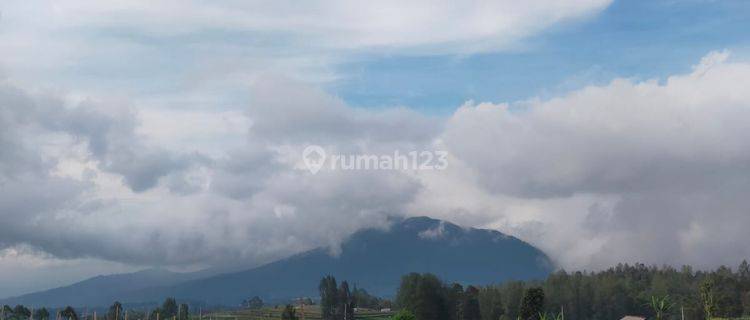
[{"left": 329, "top": 0, "right": 750, "bottom": 113}]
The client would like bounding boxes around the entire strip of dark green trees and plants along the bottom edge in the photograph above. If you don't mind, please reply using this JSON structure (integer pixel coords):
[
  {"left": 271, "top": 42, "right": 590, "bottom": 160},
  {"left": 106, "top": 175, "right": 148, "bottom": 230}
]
[{"left": 5, "top": 262, "right": 750, "bottom": 320}]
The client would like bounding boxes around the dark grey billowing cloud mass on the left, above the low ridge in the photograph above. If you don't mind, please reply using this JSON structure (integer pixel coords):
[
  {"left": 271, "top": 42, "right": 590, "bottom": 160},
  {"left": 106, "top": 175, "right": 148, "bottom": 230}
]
[{"left": 0, "top": 74, "right": 437, "bottom": 266}]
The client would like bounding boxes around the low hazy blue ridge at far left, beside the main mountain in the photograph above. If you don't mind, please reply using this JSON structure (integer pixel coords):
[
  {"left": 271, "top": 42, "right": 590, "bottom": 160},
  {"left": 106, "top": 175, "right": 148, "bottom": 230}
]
[{"left": 0, "top": 269, "right": 206, "bottom": 307}]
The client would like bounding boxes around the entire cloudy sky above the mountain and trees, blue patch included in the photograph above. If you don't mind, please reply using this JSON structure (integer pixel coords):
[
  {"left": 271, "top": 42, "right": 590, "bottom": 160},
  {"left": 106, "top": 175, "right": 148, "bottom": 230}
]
[{"left": 0, "top": 0, "right": 750, "bottom": 297}]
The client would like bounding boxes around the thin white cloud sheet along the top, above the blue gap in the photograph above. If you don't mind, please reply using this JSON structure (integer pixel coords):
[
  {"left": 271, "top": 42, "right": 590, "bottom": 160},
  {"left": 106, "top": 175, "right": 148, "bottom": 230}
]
[{"left": 0, "top": 0, "right": 611, "bottom": 96}]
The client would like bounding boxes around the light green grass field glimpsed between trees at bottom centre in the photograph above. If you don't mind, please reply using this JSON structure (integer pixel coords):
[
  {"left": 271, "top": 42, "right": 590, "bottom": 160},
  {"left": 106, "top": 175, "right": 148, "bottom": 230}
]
[{"left": 202, "top": 306, "right": 393, "bottom": 320}]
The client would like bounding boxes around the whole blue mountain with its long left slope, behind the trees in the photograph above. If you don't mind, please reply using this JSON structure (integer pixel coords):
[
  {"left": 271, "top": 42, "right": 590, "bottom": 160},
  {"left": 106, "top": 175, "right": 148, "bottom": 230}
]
[{"left": 0, "top": 217, "right": 553, "bottom": 306}]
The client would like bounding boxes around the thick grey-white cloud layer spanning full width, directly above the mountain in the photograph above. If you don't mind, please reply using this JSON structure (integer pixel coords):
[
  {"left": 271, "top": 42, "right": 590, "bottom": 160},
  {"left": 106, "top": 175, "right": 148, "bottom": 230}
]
[{"left": 0, "top": 52, "right": 750, "bottom": 298}]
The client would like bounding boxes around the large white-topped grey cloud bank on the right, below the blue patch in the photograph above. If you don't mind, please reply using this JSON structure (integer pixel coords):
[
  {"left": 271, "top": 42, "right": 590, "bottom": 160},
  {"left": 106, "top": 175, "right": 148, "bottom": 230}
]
[{"left": 428, "top": 53, "right": 750, "bottom": 268}]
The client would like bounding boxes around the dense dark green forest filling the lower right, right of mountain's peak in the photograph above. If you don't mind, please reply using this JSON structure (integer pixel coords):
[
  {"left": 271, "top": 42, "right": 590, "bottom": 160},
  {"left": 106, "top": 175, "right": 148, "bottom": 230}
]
[{"left": 388, "top": 261, "right": 750, "bottom": 320}]
